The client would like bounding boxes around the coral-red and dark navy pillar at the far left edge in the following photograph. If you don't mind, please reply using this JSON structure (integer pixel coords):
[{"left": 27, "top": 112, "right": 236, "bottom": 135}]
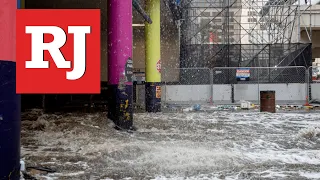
[{"left": 0, "top": 0, "right": 21, "bottom": 180}]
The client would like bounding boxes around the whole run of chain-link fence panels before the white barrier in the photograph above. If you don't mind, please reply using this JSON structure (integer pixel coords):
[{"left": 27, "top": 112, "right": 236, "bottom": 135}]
[{"left": 162, "top": 66, "right": 308, "bottom": 105}]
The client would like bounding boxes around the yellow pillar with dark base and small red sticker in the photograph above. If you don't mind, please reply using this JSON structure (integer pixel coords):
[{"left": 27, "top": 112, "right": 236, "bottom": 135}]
[{"left": 145, "top": 0, "right": 161, "bottom": 112}]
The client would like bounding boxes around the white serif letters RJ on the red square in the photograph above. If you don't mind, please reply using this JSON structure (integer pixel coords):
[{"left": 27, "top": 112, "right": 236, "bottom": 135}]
[{"left": 25, "top": 26, "right": 91, "bottom": 80}]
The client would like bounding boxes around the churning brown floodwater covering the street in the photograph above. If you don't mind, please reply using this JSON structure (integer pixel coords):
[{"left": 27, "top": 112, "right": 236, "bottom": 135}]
[{"left": 21, "top": 111, "right": 320, "bottom": 180}]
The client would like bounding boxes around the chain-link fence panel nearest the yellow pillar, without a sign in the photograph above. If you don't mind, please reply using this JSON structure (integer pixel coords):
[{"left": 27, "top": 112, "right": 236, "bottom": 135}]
[{"left": 162, "top": 68, "right": 212, "bottom": 105}]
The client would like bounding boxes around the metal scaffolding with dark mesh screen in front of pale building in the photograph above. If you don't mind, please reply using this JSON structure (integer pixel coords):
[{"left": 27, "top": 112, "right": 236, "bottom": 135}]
[{"left": 165, "top": 0, "right": 312, "bottom": 83}]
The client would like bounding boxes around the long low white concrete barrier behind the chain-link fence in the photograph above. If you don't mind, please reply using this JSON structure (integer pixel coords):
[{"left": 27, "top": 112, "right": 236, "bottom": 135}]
[{"left": 162, "top": 83, "right": 308, "bottom": 104}]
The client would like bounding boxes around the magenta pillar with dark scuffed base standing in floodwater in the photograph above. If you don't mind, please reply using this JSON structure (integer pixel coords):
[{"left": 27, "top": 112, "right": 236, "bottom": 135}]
[{"left": 108, "top": 0, "right": 133, "bottom": 129}]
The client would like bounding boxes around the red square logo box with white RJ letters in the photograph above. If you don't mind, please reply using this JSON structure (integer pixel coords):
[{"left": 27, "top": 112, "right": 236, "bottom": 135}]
[{"left": 16, "top": 9, "right": 100, "bottom": 94}]
